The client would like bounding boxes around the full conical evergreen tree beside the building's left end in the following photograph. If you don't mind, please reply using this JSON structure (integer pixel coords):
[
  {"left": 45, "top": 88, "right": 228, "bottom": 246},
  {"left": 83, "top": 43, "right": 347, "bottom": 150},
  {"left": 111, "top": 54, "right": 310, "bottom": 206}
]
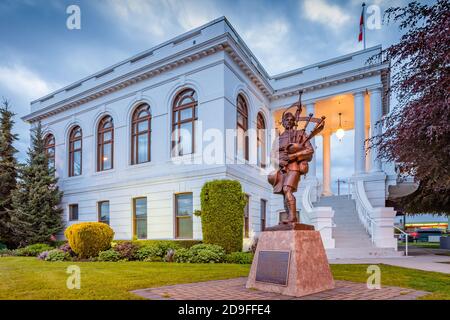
[{"left": 11, "top": 123, "right": 64, "bottom": 246}]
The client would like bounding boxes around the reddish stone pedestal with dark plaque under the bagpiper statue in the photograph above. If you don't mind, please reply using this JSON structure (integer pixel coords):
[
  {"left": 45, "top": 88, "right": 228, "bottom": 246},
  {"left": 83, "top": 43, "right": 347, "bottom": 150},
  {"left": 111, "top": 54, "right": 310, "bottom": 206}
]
[{"left": 246, "top": 229, "right": 334, "bottom": 297}]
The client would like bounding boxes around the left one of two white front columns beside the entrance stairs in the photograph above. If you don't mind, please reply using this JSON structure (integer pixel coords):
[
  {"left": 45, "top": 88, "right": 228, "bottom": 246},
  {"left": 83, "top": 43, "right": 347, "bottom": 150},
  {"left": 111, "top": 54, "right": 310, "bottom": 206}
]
[{"left": 353, "top": 92, "right": 365, "bottom": 175}]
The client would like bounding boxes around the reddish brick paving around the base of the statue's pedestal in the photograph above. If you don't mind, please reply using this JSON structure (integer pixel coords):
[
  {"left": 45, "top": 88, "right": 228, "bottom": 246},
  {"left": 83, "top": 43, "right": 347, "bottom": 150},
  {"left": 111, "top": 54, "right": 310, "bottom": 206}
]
[{"left": 132, "top": 277, "right": 428, "bottom": 300}]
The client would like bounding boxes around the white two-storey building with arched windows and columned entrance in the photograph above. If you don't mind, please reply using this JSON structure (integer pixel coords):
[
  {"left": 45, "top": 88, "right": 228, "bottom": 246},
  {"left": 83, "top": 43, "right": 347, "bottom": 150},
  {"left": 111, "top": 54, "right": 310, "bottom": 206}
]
[{"left": 23, "top": 18, "right": 404, "bottom": 256}]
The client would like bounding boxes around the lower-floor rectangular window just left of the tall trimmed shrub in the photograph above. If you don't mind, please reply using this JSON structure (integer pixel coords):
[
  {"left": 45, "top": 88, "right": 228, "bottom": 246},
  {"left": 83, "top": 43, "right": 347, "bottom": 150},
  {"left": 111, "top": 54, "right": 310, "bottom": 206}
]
[{"left": 175, "top": 193, "right": 194, "bottom": 239}]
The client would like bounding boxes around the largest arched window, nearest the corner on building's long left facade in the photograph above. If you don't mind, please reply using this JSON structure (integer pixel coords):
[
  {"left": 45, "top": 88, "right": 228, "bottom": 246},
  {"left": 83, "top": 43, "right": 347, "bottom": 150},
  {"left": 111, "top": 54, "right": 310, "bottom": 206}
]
[{"left": 172, "top": 89, "right": 198, "bottom": 156}]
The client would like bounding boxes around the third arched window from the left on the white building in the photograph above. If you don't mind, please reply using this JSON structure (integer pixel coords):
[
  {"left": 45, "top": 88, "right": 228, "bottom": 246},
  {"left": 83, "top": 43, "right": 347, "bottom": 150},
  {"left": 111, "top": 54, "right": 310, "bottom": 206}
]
[{"left": 97, "top": 116, "right": 114, "bottom": 171}]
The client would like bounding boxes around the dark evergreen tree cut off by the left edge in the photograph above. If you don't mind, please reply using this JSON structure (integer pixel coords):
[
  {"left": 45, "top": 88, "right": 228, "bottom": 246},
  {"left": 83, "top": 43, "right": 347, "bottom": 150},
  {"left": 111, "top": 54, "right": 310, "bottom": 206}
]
[{"left": 0, "top": 100, "right": 17, "bottom": 246}]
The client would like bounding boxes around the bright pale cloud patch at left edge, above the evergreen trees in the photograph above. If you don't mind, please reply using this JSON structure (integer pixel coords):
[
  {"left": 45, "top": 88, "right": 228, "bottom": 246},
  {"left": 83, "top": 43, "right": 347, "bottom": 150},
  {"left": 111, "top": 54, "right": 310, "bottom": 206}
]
[{"left": 0, "top": 64, "right": 58, "bottom": 101}]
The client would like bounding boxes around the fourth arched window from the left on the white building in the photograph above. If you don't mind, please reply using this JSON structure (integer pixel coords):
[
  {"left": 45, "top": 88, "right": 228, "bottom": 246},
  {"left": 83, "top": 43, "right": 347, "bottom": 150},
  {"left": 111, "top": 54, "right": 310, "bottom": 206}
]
[{"left": 131, "top": 103, "right": 152, "bottom": 164}]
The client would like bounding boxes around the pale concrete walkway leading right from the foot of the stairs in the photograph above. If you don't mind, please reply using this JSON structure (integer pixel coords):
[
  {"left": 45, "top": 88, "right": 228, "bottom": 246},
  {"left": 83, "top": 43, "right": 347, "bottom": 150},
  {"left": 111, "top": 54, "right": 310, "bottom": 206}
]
[{"left": 329, "top": 248, "right": 450, "bottom": 274}]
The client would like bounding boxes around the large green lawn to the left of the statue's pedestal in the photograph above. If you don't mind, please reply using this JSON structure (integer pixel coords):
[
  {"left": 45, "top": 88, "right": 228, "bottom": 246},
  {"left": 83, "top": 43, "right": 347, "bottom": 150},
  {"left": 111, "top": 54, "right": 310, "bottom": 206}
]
[{"left": 0, "top": 257, "right": 249, "bottom": 299}]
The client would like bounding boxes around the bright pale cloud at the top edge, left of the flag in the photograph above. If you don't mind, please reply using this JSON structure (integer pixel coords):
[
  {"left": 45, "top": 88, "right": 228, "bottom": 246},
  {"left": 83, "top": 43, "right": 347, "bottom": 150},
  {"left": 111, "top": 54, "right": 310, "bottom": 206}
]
[{"left": 303, "top": 0, "right": 350, "bottom": 30}]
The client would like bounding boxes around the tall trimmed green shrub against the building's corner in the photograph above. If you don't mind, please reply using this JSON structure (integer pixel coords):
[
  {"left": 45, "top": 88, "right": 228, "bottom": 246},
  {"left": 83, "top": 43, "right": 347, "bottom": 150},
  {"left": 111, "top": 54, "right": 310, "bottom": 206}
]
[{"left": 200, "top": 180, "right": 246, "bottom": 252}]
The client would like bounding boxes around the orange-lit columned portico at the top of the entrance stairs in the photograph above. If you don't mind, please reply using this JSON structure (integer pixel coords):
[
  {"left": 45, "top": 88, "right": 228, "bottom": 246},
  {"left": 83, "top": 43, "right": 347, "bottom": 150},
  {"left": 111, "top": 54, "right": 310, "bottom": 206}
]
[{"left": 274, "top": 86, "right": 383, "bottom": 196}]
